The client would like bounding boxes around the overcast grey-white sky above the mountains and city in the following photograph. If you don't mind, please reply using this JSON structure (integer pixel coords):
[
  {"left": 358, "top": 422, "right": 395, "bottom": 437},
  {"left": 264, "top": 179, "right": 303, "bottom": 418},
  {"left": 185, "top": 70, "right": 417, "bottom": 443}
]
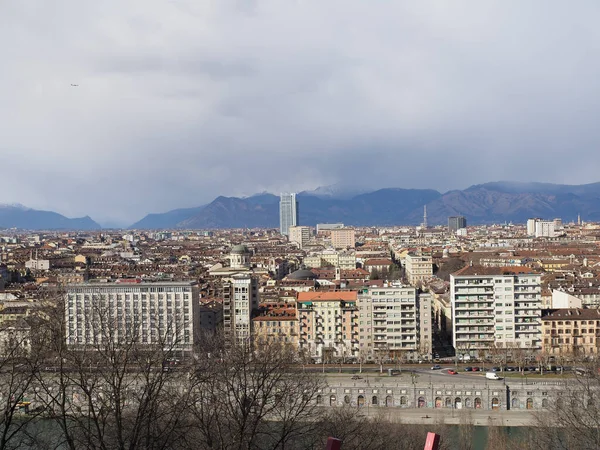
[{"left": 0, "top": 0, "right": 600, "bottom": 226}]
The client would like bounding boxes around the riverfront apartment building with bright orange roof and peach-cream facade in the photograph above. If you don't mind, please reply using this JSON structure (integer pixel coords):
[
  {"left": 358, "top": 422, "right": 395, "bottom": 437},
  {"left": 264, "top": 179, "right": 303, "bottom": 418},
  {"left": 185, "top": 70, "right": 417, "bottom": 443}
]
[{"left": 296, "top": 291, "right": 358, "bottom": 362}]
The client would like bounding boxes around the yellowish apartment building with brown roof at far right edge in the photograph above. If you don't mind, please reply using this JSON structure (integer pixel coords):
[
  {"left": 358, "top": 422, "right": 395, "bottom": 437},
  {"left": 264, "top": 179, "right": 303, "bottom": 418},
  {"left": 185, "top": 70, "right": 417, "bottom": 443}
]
[{"left": 542, "top": 308, "right": 600, "bottom": 357}]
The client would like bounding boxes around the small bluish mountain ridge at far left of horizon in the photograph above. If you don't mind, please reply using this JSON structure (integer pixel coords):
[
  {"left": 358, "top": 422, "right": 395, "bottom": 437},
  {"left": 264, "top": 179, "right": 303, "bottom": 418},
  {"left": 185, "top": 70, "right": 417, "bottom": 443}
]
[{"left": 0, "top": 204, "right": 101, "bottom": 230}]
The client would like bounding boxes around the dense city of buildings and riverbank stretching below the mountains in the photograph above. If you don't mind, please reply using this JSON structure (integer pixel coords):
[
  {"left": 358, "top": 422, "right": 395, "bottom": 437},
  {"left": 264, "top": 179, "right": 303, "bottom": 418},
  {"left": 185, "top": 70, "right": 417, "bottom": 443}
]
[{"left": 0, "top": 194, "right": 600, "bottom": 448}]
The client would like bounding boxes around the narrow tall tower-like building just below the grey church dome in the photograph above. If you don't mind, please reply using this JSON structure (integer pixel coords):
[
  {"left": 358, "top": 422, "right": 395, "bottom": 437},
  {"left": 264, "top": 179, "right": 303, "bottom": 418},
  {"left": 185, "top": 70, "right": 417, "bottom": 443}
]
[{"left": 223, "top": 274, "right": 258, "bottom": 345}]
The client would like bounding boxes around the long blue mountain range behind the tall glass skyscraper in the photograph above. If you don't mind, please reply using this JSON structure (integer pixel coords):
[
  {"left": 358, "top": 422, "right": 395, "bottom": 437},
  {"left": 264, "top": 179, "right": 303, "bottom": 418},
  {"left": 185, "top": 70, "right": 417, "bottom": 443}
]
[{"left": 131, "top": 181, "right": 600, "bottom": 229}]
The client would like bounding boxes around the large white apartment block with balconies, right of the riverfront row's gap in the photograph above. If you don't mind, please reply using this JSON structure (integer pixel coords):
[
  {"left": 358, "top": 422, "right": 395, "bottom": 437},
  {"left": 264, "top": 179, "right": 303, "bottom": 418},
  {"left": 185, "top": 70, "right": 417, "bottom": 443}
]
[{"left": 450, "top": 266, "right": 542, "bottom": 356}]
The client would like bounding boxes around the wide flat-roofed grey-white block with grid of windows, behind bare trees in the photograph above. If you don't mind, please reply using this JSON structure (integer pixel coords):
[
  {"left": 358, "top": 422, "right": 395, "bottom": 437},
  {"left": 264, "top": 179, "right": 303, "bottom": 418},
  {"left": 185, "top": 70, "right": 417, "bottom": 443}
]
[{"left": 65, "top": 280, "right": 199, "bottom": 351}]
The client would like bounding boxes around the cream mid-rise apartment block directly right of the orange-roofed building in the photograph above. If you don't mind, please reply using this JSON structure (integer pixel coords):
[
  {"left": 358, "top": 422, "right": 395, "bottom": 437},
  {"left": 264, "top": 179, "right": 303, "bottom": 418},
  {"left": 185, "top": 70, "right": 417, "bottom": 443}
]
[{"left": 358, "top": 284, "right": 432, "bottom": 360}]
